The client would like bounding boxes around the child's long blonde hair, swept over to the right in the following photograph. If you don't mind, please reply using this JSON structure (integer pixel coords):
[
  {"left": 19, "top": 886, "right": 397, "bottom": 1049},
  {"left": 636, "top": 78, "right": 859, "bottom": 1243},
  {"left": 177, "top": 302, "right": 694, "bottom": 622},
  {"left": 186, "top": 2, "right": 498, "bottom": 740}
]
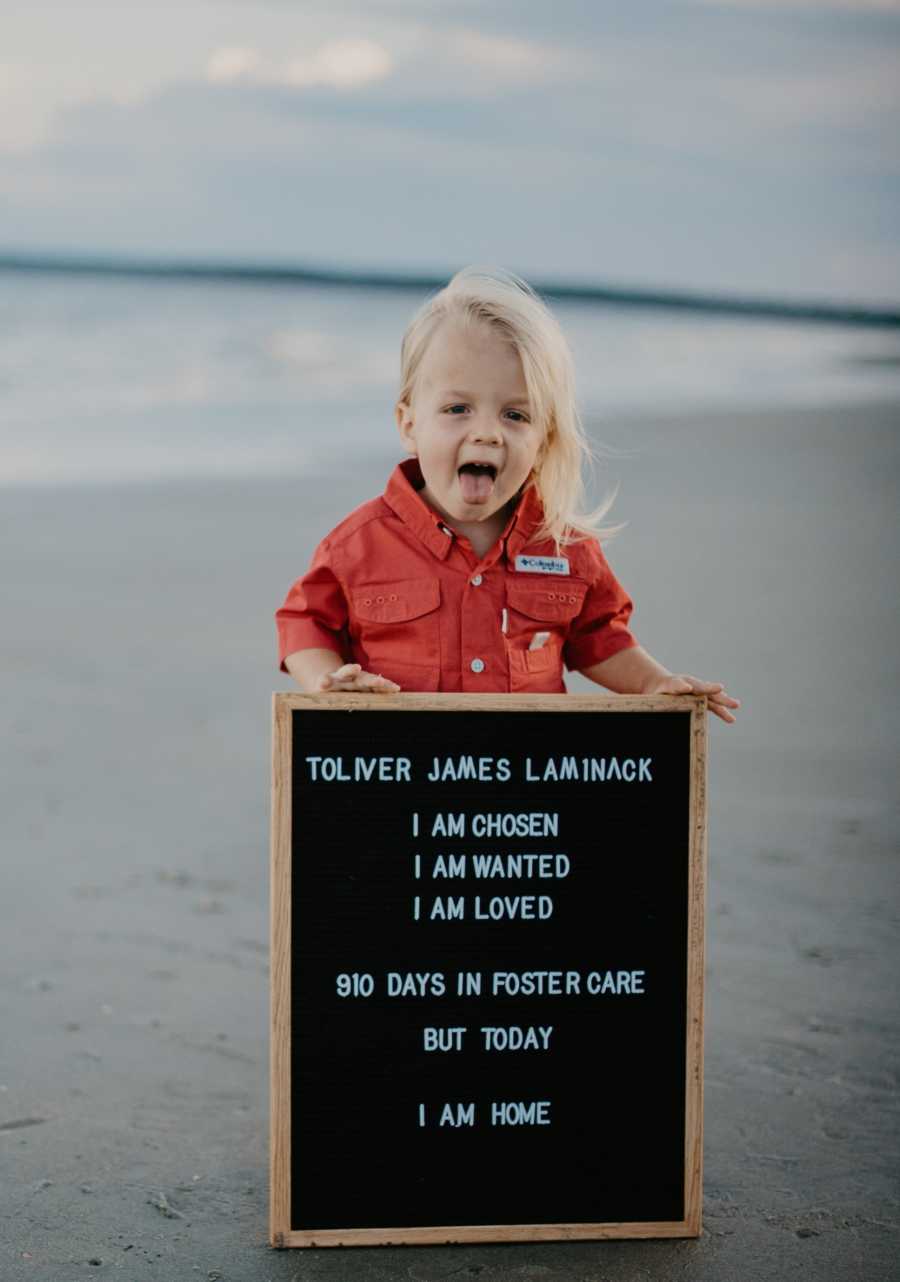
[{"left": 397, "top": 267, "right": 623, "bottom": 546}]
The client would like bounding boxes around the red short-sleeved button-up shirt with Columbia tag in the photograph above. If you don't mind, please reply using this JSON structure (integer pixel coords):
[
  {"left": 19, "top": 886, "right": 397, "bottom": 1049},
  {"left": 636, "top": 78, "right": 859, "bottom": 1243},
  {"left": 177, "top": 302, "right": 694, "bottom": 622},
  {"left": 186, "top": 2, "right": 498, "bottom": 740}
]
[{"left": 276, "top": 459, "right": 637, "bottom": 694}]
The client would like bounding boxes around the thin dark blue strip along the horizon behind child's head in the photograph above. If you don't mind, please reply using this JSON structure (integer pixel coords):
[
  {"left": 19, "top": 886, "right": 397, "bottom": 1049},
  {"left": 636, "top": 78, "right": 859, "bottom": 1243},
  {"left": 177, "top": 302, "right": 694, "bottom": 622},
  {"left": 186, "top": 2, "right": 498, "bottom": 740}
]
[{"left": 0, "top": 250, "right": 900, "bottom": 328}]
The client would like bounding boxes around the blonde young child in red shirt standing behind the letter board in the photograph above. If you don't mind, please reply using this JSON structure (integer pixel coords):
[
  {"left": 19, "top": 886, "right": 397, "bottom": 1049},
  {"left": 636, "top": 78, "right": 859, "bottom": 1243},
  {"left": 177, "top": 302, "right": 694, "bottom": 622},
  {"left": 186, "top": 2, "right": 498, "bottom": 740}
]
[{"left": 276, "top": 268, "right": 740, "bottom": 722}]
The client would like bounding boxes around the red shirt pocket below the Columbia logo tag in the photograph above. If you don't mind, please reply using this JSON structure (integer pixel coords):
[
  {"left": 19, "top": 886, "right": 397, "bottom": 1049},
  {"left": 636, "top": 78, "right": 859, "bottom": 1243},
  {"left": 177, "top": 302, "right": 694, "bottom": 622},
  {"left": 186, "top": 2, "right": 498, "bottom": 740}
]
[{"left": 505, "top": 578, "right": 587, "bottom": 692}]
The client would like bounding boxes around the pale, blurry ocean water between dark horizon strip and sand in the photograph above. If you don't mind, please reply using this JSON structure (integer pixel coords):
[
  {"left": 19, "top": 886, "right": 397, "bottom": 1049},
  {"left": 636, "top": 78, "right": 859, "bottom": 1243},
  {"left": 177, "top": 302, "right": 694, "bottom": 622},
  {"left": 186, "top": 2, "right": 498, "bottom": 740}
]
[{"left": 0, "top": 272, "right": 900, "bottom": 485}]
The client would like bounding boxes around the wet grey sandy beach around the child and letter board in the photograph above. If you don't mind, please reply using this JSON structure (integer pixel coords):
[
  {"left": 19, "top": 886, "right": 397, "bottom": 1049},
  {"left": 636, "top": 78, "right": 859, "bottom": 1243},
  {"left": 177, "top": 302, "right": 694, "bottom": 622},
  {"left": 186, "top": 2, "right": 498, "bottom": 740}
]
[{"left": 0, "top": 394, "right": 900, "bottom": 1282}]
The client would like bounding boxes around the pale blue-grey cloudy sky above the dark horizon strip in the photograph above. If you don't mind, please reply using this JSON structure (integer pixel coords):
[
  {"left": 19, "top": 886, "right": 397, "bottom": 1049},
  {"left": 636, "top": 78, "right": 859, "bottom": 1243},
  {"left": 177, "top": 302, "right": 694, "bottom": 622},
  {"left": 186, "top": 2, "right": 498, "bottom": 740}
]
[{"left": 0, "top": 0, "right": 900, "bottom": 305}]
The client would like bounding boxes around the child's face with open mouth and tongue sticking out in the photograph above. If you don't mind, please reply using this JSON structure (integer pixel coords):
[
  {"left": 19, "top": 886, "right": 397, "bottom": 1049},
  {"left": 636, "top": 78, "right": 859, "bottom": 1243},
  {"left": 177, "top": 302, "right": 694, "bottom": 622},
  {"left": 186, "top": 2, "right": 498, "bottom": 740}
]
[{"left": 396, "top": 323, "right": 542, "bottom": 542}]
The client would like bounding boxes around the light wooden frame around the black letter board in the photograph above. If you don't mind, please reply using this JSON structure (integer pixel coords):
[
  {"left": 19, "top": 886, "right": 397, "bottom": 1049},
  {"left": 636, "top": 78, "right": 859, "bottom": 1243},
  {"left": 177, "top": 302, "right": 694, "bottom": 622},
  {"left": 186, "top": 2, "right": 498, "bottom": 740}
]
[{"left": 269, "top": 692, "right": 708, "bottom": 1247}]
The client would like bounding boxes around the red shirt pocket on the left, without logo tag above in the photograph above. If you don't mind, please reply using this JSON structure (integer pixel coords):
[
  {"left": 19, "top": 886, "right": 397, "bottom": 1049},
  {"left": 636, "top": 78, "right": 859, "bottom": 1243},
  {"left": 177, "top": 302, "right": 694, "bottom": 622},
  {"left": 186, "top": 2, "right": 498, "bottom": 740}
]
[{"left": 351, "top": 578, "right": 441, "bottom": 690}]
